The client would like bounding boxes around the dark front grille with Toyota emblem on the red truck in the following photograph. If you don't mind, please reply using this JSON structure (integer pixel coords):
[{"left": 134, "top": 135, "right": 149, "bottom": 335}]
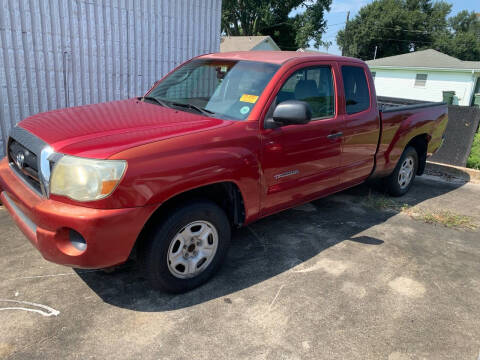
[{"left": 7, "top": 138, "right": 41, "bottom": 193}]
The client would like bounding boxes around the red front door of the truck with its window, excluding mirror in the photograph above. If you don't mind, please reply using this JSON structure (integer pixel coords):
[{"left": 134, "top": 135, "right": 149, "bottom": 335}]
[{"left": 262, "top": 63, "right": 343, "bottom": 215}]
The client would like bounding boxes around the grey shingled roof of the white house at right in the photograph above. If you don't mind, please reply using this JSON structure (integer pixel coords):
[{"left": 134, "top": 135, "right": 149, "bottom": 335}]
[{"left": 366, "top": 49, "right": 480, "bottom": 71}]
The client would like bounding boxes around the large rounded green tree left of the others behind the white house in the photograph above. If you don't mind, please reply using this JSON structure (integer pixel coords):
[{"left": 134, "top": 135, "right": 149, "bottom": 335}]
[{"left": 337, "top": 0, "right": 452, "bottom": 60}]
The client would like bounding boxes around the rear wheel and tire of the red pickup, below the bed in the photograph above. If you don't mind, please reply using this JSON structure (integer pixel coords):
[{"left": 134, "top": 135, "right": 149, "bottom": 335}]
[{"left": 385, "top": 146, "right": 418, "bottom": 196}]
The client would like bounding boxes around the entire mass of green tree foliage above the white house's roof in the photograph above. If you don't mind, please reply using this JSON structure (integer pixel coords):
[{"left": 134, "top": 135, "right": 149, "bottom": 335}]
[{"left": 337, "top": 0, "right": 480, "bottom": 60}]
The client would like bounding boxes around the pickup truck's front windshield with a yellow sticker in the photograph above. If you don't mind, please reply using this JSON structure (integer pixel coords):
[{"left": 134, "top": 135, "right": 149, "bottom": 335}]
[{"left": 145, "top": 60, "right": 279, "bottom": 120}]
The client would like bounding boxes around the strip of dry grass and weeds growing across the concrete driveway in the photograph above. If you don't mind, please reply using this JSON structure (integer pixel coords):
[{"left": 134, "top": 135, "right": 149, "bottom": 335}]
[{"left": 363, "top": 191, "right": 477, "bottom": 230}]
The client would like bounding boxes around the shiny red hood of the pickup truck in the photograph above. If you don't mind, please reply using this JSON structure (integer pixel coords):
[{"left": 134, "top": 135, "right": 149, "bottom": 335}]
[{"left": 19, "top": 99, "right": 232, "bottom": 159}]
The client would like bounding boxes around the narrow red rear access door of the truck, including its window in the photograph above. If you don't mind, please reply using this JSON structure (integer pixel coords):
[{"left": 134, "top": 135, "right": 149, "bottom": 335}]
[{"left": 340, "top": 64, "right": 380, "bottom": 186}]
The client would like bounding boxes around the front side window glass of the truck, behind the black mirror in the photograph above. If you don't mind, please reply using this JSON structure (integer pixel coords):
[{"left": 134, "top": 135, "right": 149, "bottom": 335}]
[{"left": 276, "top": 66, "right": 335, "bottom": 119}]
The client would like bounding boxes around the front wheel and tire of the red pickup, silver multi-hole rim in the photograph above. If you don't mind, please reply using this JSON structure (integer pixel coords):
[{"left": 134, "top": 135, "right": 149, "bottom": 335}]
[{"left": 139, "top": 200, "right": 231, "bottom": 293}]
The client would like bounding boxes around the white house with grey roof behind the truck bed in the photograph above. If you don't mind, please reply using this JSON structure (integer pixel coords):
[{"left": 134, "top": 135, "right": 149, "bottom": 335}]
[{"left": 367, "top": 49, "right": 480, "bottom": 106}]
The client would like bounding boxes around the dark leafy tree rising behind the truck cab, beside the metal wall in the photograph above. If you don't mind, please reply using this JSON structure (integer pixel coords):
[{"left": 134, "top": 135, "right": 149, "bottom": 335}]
[{"left": 222, "top": 0, "right": 332, "bottom": 50}]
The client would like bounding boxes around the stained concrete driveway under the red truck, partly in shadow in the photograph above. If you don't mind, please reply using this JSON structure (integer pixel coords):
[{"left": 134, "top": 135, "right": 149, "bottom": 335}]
[{"left": 0, "top": 176, "right": 480, "bottom": 360}]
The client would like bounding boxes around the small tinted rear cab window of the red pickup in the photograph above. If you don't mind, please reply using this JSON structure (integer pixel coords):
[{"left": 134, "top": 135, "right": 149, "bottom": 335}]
[{"left": 342, "top": 65, "right": 370, "bottom": 115}]
